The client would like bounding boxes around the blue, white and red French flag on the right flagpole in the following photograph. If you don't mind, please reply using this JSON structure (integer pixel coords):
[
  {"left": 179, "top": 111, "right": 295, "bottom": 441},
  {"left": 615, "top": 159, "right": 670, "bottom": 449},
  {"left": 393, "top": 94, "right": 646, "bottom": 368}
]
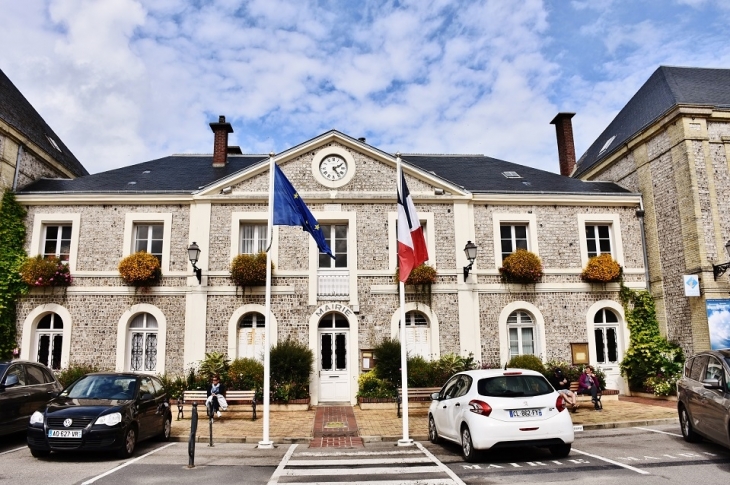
[{"left": 398, "top": 170, "right": 428, "bottom": 283}]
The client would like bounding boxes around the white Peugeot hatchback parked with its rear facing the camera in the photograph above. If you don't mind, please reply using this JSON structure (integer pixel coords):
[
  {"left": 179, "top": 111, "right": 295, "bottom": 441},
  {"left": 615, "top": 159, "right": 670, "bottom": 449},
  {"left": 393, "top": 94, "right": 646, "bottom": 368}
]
[{"left": 428, "top": 369, "right": 575, "bottom": 462}]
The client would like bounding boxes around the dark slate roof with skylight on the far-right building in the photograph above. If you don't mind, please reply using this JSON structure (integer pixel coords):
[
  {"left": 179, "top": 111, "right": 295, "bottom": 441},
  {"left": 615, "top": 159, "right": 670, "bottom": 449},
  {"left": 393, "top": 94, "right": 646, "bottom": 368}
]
[{"left": 573, "top": 66, "right": 730, "bottom": 177}]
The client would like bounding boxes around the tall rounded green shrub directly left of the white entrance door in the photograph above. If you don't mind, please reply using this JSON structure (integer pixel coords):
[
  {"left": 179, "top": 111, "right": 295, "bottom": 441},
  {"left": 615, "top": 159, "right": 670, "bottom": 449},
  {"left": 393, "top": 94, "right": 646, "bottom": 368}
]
[{"left": 269, "top": 338, "right": 314, "bottom": 402}]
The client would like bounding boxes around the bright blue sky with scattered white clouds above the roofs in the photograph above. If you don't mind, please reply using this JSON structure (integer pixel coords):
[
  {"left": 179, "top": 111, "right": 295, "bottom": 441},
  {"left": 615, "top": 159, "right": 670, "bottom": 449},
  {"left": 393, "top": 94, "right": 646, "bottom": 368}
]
[{"left": 0, "top": 0, "right": 730, "bottom": 173}]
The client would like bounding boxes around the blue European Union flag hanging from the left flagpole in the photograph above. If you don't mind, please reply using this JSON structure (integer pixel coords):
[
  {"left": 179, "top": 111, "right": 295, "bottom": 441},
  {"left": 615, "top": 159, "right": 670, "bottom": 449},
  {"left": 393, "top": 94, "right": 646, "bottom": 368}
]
[{"left": 273, "top": 164, "right": 335, "bottom": 259}]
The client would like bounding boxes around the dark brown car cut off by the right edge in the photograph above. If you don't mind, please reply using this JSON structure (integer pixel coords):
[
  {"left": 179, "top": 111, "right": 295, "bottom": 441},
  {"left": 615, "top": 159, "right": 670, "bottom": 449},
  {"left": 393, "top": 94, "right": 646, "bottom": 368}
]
[{"left": 677, "top": 349, "right": 730, "bottom": 448}]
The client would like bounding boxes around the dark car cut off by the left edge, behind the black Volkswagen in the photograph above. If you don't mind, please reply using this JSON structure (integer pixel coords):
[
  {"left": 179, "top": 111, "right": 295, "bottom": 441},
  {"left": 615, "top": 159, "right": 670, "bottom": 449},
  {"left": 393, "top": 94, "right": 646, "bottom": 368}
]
[{"left": 0, "top": 360, "right": 63, "bottom": 436}]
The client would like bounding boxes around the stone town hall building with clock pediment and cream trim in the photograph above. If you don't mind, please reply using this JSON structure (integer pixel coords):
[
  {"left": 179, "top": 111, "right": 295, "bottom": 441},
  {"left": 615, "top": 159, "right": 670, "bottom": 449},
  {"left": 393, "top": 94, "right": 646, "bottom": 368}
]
[{"left": 17, "top": 117, "right": 646, "bottom": 403}]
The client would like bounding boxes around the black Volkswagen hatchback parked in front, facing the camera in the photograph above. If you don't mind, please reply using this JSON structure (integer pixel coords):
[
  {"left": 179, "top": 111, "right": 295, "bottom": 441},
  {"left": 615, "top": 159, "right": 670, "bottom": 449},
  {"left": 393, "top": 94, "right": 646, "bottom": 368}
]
[{"left": 28, "top": 372, "right": 172, "bottom": 458}]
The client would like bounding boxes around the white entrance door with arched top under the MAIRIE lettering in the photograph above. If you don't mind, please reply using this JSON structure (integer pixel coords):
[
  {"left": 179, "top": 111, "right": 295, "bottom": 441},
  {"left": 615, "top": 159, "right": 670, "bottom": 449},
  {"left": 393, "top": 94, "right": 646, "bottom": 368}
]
[{"left": 319, "top": 313, "right": 350, "bottom": 402}]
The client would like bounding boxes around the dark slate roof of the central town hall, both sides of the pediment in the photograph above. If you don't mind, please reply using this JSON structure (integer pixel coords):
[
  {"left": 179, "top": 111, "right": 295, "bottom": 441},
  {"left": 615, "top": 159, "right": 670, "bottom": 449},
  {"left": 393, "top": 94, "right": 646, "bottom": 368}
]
[{"left": 20, "top": 154, "right": 628, "bottom": 194}]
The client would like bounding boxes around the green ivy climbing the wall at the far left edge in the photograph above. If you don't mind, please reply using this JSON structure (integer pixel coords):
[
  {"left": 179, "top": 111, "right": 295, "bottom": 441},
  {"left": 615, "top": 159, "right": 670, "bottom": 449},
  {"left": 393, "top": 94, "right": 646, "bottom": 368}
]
[{"left": 0, "top": 190, "right": 28, "bottom": 358}]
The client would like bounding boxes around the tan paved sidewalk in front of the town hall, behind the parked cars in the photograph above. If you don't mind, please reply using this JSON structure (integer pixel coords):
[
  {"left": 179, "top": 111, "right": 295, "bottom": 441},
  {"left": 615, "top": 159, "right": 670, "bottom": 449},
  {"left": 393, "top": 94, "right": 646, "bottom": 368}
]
[{"left": 172, "top": 396, "right": 677, "bottom": 446}]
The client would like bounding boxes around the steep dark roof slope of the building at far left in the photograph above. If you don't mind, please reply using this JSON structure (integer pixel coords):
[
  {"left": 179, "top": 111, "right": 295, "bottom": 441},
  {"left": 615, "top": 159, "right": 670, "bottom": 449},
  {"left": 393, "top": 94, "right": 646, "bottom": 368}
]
[{"left": 0, "top": 69, "right": 89, "bottom": 177}]
